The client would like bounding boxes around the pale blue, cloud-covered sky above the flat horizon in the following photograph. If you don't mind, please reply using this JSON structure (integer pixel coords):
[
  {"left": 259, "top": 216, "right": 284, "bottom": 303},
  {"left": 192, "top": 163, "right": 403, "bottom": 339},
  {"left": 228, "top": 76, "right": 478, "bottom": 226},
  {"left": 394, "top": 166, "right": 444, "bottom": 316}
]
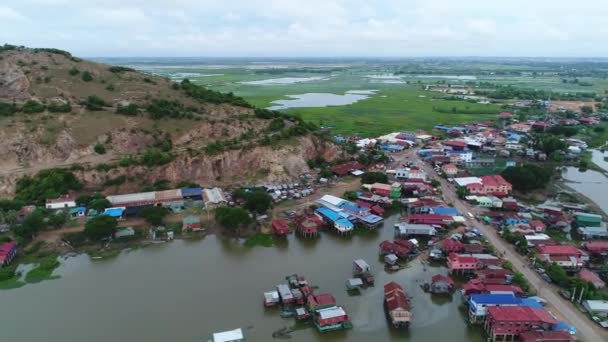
[{"left": 0, "top": 0, "right": 608, "bottom": 57}]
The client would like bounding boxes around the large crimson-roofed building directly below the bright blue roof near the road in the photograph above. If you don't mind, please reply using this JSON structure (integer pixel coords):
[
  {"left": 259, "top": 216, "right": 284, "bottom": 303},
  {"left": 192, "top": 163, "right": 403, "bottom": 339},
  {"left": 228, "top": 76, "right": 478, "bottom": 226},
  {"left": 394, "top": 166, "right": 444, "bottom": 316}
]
[{"left": 485, "top": 306, "right": 557, "bottom": 341}]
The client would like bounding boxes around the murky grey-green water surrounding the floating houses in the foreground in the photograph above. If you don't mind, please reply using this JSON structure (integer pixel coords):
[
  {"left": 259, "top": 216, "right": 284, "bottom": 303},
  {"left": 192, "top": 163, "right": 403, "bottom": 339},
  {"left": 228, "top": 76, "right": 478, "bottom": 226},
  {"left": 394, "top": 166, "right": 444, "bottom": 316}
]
[{"left": 0, "top": 217, "right": 483, "bottom": 342}]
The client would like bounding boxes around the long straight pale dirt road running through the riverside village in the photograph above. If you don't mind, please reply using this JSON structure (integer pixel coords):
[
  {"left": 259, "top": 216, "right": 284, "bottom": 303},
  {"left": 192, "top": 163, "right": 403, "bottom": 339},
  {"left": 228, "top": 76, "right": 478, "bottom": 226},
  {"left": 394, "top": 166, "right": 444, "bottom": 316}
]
[{"left": 414, "top": 157, "right": 608, "bottom": 342}]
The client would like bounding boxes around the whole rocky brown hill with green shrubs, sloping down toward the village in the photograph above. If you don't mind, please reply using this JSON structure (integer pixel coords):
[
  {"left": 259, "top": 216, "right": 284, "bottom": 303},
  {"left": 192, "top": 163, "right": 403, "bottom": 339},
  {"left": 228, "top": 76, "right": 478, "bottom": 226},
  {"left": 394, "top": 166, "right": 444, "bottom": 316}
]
[{"left": 0, "top": 45, "right": 343, "bottom": 196}]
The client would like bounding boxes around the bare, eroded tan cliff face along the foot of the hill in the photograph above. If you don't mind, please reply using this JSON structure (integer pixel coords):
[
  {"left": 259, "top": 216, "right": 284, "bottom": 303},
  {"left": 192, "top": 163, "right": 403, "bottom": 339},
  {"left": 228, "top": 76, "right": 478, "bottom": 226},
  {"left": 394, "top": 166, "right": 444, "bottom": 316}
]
[{"left": 0, "top": 136, "right": 345, "bottom": 196}]
